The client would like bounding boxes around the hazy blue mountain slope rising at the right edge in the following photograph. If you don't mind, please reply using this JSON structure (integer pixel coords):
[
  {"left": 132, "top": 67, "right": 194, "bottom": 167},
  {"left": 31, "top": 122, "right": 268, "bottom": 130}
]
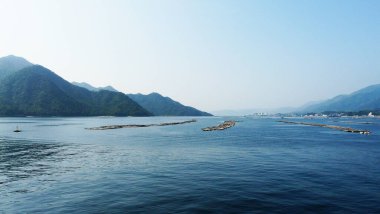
[{"left": 302, "top": 84, "right": 380, "bottom": 112}]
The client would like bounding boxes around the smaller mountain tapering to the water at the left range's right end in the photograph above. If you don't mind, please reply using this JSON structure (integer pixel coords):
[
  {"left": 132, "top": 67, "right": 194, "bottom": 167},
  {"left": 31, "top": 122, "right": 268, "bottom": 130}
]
[{"left": 128, "top": 93, "right": 212, "bottom": 116}]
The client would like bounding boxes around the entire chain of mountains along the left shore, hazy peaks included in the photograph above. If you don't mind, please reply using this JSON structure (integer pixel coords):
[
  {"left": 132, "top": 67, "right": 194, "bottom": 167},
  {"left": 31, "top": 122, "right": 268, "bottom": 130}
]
[{"left": 0, "top": 55, "right": 211, "bottom": 116}]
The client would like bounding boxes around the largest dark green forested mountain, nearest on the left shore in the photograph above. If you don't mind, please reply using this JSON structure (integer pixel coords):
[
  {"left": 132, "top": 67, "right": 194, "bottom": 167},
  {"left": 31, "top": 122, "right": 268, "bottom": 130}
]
[{"left": 0, "top": 58, "right": 152, "bottom": 116}]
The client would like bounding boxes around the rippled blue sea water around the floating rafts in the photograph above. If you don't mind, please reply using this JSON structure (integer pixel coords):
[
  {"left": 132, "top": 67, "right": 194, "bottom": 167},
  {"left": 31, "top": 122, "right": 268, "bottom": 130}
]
[{"left": 0, "top": 117, "right": 380, "bottom": 213}]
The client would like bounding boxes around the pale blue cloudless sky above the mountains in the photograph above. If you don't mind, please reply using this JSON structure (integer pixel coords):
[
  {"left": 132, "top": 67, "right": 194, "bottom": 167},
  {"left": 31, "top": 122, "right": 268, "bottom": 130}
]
[{"left": 0, "top": 0, "right": 380, "bottom": 111}]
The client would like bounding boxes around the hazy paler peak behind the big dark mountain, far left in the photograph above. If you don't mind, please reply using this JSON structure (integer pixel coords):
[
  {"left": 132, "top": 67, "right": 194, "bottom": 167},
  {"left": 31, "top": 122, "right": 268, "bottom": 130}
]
[{"left": 0, "top": 55, "right": 33, "bottom": 81}]
